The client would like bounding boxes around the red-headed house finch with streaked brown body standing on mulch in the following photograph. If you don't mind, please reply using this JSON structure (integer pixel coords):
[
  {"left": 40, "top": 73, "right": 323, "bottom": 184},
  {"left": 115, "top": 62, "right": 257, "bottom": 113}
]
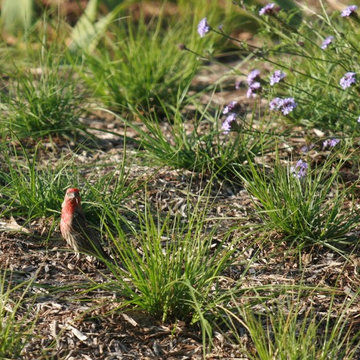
[{"left": 60, "top": 188, "right": 113, "bottom": 262}]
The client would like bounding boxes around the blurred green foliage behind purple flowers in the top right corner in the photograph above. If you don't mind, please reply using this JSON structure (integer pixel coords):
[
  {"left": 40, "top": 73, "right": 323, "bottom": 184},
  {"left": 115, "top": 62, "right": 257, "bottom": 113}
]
[{"left": 243, "top": 1, "right": 360, "bottom": 134}]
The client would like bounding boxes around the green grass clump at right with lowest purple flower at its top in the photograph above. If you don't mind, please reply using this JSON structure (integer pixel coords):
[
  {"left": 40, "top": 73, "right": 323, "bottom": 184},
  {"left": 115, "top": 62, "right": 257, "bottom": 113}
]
[{"left": 238, "top": 146, "right": 359, "bottom": 246}]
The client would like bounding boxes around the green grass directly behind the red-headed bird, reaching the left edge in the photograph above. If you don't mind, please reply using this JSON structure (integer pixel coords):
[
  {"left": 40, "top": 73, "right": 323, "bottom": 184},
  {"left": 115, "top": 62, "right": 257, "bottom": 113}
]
[{"left": 0, "top": 136, "right": 136, "bottom": 229}]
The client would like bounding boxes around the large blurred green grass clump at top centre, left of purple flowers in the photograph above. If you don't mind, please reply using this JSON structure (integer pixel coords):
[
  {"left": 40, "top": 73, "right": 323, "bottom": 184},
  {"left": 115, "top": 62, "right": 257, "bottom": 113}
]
[{"left": 78, "top": 10, "right": 212, "bottom": 112}]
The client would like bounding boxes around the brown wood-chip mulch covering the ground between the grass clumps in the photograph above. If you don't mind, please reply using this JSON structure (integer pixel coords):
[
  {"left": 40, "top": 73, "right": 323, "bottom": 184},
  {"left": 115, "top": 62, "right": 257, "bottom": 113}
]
[{"left": 0, "top": 58, "right": 360, "bottom": 360}]
